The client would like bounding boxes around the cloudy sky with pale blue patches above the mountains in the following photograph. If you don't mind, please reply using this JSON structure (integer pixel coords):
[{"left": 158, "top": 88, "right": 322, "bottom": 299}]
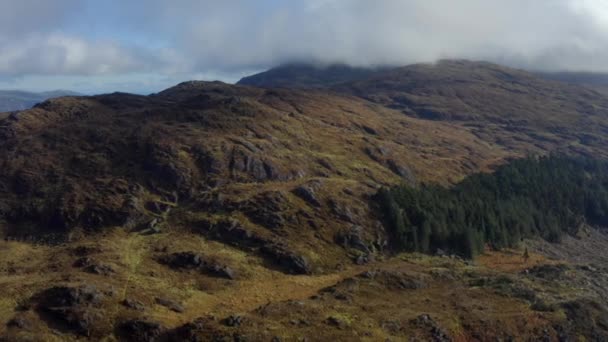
[{"left": 0, "top": 0, "right": 608, "bottom": 93}]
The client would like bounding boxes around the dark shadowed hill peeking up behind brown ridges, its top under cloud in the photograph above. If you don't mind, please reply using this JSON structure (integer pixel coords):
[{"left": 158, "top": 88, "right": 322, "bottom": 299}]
[{"left": 237, "top": 64, "right": 386, "bottom": 89}]
